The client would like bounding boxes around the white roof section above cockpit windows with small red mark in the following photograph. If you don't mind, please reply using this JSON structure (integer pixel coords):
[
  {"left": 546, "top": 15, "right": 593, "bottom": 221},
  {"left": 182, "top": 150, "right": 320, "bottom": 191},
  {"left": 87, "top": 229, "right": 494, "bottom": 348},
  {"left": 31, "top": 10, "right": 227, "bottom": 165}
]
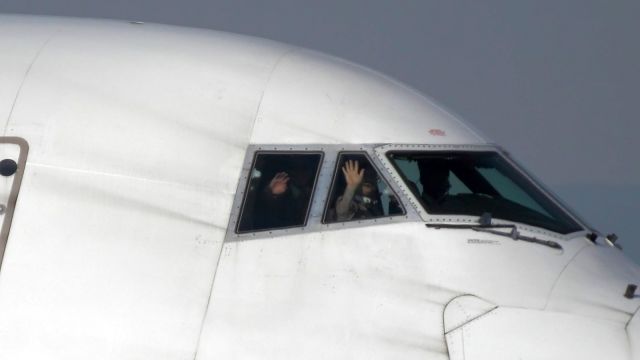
[{"left": 251, "top": 51, "right": 486, "bottom": 144}]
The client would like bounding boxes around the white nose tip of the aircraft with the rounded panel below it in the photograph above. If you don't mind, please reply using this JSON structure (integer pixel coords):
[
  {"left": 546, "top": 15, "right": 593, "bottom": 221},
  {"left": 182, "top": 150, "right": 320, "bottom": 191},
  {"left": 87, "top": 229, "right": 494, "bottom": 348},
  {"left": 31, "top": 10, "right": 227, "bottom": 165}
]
[{"left": 444, "top": 244, "right": 640, "bottom": 360}]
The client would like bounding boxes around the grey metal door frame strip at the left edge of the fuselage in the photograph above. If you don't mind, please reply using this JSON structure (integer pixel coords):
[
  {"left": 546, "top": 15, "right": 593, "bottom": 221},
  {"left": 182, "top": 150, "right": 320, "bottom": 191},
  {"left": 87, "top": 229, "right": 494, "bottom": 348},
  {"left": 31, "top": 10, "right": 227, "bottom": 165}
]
[{"left": 0, "top": 136, "right": 29, "bottom": 270}]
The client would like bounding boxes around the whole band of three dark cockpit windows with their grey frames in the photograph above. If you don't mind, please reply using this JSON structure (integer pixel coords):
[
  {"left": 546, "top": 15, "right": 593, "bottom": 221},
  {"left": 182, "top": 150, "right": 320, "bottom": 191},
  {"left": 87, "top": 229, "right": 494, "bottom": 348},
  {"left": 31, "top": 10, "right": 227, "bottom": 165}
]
[{"left": 229, "top": 145, "right": 586, "bottom": 239}]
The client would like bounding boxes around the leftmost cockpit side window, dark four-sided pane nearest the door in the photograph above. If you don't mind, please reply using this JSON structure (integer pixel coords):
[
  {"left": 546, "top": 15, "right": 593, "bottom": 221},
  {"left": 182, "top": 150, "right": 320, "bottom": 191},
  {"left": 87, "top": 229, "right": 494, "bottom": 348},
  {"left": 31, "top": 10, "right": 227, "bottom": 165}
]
[{"left": 236, "top": 152, "right": 322, "bottom": 233}]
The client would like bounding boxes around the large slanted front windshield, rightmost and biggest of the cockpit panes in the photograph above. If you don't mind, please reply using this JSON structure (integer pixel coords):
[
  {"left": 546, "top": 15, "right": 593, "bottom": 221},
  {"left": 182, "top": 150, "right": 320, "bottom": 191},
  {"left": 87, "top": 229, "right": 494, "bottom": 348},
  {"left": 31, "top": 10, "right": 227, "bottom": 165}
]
[{"left": 387, "top": 151, "right": 582, "bottom": 234}]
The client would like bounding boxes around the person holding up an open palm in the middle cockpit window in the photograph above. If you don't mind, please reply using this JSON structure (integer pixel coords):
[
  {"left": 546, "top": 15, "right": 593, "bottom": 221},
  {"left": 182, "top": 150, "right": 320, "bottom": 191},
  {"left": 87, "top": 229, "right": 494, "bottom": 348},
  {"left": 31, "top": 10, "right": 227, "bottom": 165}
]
[{"left": 335, "top": 160, "right": 384, "bottom": 221}]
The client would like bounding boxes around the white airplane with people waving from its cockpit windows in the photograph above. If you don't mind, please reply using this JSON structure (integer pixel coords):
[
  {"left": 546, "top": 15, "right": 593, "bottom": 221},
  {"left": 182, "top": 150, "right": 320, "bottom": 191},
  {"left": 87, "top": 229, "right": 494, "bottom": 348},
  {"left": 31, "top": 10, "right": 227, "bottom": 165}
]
[{"left": 0, "top": 15, "right": 640, "bottom": 360}]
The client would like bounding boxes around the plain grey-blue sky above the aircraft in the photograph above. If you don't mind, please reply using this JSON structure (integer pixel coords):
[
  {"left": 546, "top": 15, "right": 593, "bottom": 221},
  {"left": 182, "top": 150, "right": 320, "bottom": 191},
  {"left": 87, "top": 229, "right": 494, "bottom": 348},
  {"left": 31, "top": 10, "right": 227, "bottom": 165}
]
[{"left": 0, "top": 0, "right": 640, "bottom": 262}]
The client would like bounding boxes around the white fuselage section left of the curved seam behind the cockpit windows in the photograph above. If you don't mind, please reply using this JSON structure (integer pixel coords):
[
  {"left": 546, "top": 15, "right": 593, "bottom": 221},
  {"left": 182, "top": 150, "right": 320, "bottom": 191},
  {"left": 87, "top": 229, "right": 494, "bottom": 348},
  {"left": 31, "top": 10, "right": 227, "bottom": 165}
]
[{"left": 0, "top": 16, "right": 286, "bottom": 359}]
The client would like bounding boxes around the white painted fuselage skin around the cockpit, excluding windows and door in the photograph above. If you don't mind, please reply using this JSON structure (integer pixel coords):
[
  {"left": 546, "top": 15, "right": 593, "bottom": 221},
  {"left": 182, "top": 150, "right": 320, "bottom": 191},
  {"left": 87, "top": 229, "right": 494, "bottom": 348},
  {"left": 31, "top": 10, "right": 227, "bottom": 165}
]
[{"left": 0, "top": 16, "right": 640, "bottom": 360}]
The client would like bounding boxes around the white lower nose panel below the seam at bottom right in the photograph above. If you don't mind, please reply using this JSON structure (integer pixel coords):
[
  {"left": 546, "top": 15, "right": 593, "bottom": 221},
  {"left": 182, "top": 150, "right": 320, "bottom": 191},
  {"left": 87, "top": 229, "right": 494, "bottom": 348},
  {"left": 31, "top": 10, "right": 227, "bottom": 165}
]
[{"left": 446, "top": 308, "right": 629, "bottom": 360}]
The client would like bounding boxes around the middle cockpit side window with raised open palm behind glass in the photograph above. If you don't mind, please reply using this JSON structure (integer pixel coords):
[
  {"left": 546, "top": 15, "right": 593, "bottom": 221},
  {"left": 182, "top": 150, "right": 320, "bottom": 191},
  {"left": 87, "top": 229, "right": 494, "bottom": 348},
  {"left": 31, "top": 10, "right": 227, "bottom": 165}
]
[{"left": 323, "top": 153, "right": 404, "bottom": 223}]
